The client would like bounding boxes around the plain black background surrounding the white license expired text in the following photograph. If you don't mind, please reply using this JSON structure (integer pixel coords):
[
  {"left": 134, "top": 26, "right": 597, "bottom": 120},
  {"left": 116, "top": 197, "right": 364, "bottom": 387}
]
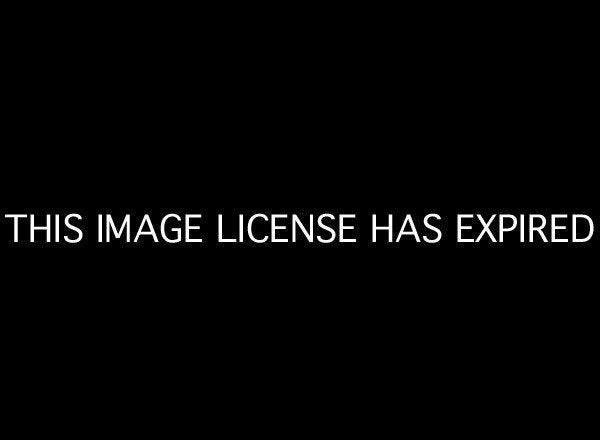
[{"left": 1, "top": 5, "right": 598, "bottom": 433}]
